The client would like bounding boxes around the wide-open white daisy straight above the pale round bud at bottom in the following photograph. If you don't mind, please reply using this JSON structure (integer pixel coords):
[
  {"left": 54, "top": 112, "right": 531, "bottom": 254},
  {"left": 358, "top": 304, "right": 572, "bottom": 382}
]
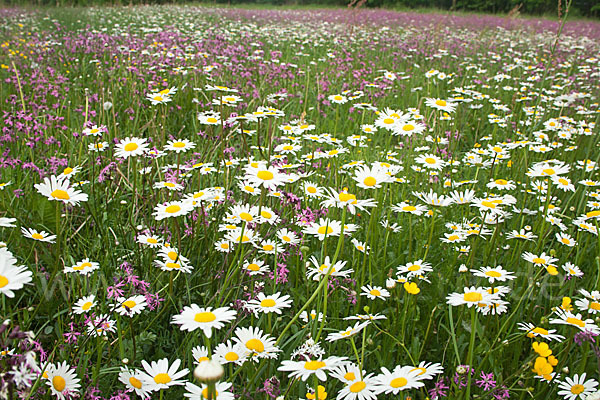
[{"left": 171, "top": 304, "right": 236, "bottom": 338}]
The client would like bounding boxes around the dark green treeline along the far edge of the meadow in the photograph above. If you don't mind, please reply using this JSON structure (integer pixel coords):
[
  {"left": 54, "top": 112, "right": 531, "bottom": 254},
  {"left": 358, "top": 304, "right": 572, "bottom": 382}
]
[{"left": 0, "top": 0, "right": 600, "bottom": 18}]
